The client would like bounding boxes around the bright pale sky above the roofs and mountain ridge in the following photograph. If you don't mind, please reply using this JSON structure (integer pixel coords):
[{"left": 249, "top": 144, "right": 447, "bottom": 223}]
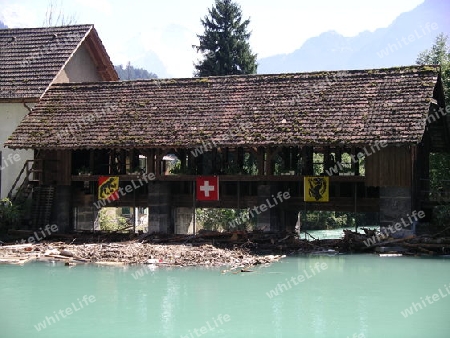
[{"left": 0, "top": 0, "right": 424, "bottom": 77}]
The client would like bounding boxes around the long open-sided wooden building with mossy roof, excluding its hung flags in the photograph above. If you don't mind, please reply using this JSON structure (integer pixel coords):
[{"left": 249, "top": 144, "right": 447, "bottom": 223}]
[{"left": 6, "top": 66, "right": 450, "bottom": 233}]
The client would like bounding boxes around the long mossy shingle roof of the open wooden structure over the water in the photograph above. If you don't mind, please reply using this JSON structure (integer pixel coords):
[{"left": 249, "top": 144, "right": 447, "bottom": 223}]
[{"left": 6, "top": 66, "right": 440, "bottom": 149}]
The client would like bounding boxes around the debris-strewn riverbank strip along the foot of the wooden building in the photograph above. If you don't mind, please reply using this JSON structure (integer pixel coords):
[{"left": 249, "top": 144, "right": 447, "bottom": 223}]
[{"left": 0, "top": 229, "right": 450, "bottom": 271}]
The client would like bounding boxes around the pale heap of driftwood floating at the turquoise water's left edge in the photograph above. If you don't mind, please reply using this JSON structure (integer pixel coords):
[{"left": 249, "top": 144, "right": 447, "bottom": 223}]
[{"left": 0, "top": 242, "right": 282, "bottom": 268}]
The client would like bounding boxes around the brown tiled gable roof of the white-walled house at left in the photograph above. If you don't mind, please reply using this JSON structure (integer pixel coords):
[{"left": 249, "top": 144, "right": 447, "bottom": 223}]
[{"left": 0, "top": 25, "right": 118, "bottom": 101}]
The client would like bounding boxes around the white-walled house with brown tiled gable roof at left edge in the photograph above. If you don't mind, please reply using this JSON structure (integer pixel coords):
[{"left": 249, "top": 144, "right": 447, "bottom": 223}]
[{"left": 0, "top": 25, "right": 118, "bottom": 198}]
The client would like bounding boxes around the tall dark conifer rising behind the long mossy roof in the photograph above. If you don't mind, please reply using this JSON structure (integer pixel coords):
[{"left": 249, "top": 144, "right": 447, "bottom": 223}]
[{"left": 193, "top": 0, "right": 257, "bottom": 77}]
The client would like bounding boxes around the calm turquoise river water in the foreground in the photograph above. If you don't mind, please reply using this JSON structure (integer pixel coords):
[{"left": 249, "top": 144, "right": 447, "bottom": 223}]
[{"left": 0, "top": 255, "right": 450, "bottom": 338}]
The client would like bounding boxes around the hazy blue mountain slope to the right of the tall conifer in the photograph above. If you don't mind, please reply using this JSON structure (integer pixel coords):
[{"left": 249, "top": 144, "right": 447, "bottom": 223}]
[{"left": 258, "top": 0, "right": 450, "bottom": 74}]
